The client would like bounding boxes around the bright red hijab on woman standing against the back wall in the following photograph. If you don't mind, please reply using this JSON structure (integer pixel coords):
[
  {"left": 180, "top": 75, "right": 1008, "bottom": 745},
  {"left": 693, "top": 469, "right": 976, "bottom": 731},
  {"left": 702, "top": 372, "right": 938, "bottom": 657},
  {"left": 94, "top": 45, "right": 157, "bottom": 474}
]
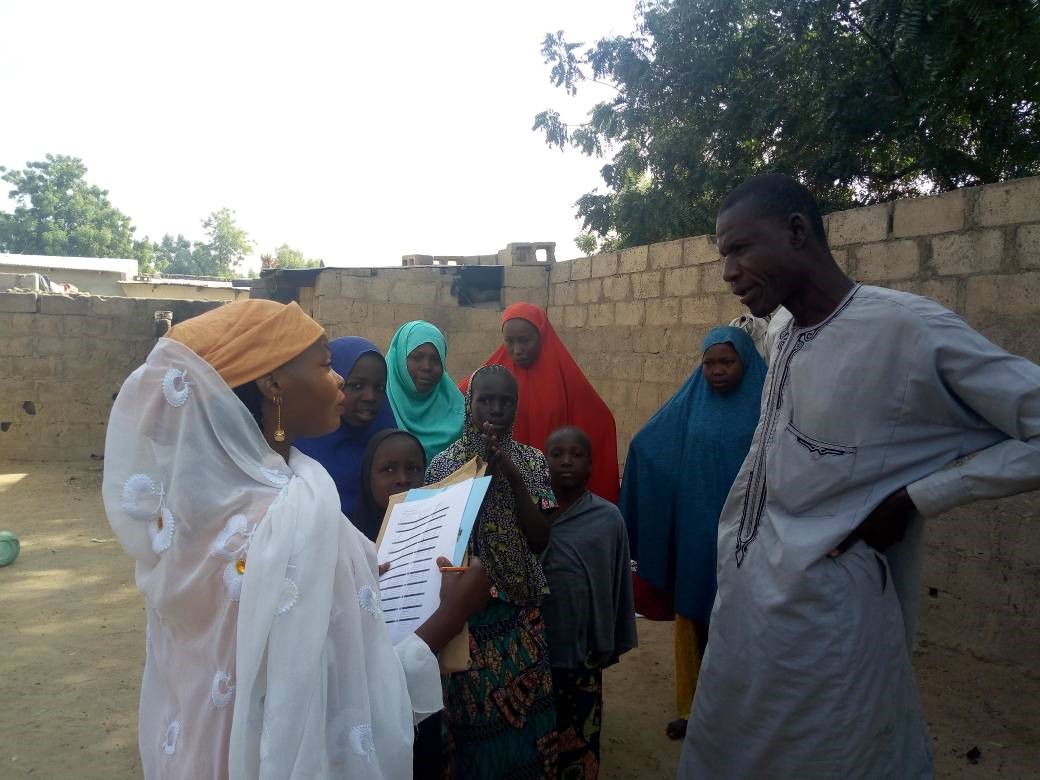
[{"left": 459, "top": 304, "right": 620, "bottom": 503}]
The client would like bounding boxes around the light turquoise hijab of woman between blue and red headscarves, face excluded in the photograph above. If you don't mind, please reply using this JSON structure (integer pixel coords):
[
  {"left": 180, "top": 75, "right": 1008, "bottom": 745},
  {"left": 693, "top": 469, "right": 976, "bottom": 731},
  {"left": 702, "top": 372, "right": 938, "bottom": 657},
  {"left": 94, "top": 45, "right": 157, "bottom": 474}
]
[{"left": 387, "top": 319, "right": 466, "bottom": 463}]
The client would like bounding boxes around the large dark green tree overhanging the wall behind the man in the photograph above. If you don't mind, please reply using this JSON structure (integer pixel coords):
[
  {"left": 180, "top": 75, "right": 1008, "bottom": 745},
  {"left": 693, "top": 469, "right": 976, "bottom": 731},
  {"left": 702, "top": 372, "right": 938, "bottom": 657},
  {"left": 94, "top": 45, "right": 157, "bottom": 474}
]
[{"left": 535, "top": 0, "right": 1040, "bottom": 250}]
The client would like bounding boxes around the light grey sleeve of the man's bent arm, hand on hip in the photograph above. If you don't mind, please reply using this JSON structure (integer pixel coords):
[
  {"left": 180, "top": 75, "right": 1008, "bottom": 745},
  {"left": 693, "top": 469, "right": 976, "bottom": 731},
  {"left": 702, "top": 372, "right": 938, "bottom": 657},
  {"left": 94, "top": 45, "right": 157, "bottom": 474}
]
[{"left": 907, "top": 312, "right": 1040, "bottom": 517}]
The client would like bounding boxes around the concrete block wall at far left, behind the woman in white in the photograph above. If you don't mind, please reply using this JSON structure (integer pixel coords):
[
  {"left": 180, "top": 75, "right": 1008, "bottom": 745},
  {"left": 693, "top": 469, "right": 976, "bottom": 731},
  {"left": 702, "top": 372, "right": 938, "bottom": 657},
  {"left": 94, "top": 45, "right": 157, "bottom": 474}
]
[{"left": 0, "top": 292, "right": 220, "bottom": 461}]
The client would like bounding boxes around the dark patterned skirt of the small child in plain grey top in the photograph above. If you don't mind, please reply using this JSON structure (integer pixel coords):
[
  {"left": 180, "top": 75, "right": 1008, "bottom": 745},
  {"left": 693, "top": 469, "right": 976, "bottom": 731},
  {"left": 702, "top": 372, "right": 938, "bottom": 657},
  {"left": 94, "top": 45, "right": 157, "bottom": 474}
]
[{"left": 552, "top": 664, "right": 603, "bottom": 780}]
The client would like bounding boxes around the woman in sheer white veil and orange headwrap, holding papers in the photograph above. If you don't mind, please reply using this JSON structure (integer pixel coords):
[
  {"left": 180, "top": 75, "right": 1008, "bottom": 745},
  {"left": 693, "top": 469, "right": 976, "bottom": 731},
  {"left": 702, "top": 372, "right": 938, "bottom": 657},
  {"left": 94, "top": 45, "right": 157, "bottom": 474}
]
[{"left": 103, "top": 301, "right": 490, "bottom": 780}]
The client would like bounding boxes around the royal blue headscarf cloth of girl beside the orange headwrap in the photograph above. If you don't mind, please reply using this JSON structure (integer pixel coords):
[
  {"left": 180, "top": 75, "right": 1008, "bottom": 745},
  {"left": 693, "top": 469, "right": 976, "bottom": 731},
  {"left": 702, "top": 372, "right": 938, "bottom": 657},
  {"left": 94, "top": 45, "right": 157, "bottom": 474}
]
[{"left": 295, "top": 336, "right": 397, "bottom": 518}]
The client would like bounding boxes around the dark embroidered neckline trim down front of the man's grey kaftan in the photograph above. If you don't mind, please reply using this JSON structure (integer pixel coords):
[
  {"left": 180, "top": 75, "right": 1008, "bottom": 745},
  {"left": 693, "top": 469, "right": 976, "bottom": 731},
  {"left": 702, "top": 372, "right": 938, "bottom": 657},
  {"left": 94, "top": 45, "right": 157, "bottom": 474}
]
[{"left": 735, "top": 284, "right": 861, "bottom": 569}]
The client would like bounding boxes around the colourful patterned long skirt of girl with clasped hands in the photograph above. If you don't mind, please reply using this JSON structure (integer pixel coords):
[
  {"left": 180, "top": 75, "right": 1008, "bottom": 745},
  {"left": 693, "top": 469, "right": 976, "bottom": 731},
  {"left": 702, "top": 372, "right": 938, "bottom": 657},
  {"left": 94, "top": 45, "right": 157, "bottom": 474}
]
[{"left": 443, "top": 599, "right": 556, "bottom": 780}]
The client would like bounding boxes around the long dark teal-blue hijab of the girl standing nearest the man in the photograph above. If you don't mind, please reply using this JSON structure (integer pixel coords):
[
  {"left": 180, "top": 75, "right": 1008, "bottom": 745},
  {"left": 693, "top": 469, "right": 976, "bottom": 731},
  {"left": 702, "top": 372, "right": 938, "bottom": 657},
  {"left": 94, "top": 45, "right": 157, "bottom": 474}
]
[{"left": 619, "top": 328, "right": 766, "bottom": 623}]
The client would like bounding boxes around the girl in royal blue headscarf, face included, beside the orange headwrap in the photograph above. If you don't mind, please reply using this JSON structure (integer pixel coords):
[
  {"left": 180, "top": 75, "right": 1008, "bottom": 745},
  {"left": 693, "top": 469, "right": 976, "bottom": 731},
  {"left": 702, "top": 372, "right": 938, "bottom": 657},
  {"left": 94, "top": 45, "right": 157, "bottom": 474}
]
[{"left": 295, "top": 336, "right": 397, "bottom": 541}]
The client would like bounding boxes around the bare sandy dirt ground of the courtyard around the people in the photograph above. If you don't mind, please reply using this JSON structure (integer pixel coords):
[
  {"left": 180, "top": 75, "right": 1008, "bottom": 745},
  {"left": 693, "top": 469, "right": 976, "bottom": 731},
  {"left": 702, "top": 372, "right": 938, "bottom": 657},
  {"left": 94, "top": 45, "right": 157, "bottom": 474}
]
[{"left": 0, "top": 463, "right": 1040, "bottom": 780}]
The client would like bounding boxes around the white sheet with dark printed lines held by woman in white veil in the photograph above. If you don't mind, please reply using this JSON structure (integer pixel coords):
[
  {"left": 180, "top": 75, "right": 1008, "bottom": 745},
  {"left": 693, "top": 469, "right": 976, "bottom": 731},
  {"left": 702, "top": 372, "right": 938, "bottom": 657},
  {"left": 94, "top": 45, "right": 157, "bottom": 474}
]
[{"left": 376, "top": 483, "right": 471, "bottom": 645}]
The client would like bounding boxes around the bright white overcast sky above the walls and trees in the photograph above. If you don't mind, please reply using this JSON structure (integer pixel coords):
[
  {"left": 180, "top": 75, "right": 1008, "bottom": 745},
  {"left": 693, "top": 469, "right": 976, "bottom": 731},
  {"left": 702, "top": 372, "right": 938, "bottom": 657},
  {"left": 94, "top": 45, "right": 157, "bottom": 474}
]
[{"left": 0, "top": 0, "right": 635, "bottom": 265}]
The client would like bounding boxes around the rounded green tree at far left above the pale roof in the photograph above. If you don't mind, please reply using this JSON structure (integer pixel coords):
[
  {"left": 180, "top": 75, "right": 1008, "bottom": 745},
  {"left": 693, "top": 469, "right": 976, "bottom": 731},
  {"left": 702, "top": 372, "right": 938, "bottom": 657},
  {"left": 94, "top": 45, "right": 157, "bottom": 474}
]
[{"left": 0, "top": 154, "right": 144, "bottom": 257}]
